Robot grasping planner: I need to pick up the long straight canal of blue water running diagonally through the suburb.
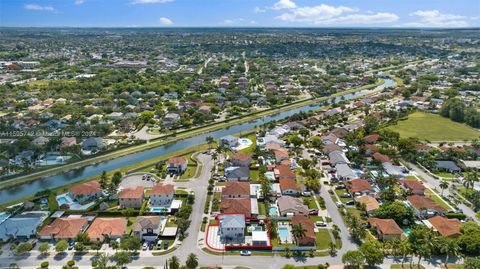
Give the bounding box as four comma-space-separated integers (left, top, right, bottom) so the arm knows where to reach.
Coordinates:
0, 79, 396, 204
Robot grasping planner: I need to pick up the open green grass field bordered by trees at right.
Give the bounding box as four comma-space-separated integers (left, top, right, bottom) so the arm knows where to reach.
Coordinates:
387, 112, 480, 141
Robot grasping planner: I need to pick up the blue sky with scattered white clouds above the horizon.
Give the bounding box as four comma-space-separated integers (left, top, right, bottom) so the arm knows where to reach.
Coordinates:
0, 0, 480, 28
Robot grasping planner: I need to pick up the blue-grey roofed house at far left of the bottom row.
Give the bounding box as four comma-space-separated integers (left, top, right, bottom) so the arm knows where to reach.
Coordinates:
0, 211, 49, 242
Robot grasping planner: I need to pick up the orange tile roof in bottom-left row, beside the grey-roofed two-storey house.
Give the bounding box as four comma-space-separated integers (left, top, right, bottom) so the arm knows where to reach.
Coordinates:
87, 218, 127, 239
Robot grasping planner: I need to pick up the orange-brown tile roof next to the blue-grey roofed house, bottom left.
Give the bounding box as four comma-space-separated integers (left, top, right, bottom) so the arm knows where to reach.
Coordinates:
38, 218, 88, 239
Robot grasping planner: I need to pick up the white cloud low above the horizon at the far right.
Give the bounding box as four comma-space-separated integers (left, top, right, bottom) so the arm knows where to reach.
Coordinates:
403, 9, 469, 27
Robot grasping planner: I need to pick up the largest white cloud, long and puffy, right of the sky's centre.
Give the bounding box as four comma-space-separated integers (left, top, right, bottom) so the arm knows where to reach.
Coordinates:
276, 4, 399, 25
